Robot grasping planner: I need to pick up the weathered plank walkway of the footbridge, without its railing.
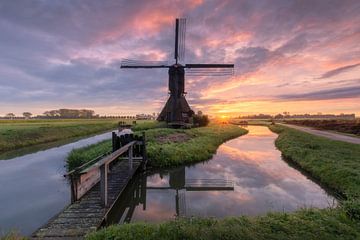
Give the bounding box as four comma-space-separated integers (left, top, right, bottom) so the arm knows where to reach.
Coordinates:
32, 160, 142, 239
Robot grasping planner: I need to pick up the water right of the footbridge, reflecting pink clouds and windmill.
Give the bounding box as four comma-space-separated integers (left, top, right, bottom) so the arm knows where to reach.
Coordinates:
109, 126, 336, 223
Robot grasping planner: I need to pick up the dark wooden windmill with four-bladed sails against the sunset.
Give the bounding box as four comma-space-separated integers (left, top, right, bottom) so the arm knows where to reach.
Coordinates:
121, 18, 234, 127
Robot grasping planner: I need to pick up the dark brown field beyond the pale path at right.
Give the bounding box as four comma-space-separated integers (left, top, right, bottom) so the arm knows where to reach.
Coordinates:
284, 120, 360, 136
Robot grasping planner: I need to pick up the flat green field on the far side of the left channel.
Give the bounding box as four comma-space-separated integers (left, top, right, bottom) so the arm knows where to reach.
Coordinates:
0, 119, 162, 158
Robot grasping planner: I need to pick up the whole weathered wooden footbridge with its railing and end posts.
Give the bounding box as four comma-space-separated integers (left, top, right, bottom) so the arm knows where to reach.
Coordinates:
31, 132, 146, 240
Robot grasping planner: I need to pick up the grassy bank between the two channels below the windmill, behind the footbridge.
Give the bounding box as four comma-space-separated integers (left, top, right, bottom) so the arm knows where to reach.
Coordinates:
67, 124, 247, 170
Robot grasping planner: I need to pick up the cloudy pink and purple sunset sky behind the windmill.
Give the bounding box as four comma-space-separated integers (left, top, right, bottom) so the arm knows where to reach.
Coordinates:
0, 0, 360, 116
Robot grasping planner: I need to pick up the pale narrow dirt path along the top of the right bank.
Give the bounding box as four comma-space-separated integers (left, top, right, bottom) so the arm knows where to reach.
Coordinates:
278, 123, 360, 144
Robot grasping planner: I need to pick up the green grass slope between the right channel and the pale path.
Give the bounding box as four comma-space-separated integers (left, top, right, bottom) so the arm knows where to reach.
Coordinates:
269, 125, 360, 197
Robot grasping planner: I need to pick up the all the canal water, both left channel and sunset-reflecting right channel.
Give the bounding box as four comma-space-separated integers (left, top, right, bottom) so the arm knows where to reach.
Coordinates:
0, 126, 336, 235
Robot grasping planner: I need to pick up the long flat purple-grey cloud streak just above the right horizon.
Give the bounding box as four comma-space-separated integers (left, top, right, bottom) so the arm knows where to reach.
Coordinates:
278, 86, 360, 101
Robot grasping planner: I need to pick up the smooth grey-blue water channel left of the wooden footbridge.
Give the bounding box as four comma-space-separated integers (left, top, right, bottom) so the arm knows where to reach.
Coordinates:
0, 133, 111, 236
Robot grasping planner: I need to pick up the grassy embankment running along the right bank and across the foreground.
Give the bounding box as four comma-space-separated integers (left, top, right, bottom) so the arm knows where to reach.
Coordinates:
87, 123, 360, 240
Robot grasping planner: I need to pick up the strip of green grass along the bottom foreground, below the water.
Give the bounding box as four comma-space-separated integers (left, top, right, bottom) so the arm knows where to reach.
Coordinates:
86, 209, 360, 240
